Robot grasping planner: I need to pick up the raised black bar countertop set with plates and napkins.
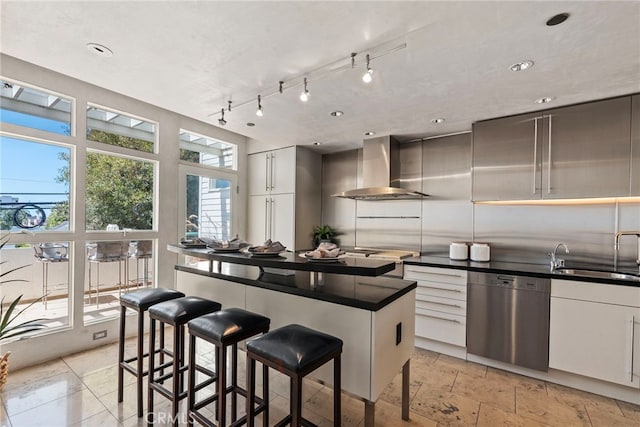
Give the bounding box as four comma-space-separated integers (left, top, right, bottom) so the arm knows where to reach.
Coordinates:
167, 245, 396, 277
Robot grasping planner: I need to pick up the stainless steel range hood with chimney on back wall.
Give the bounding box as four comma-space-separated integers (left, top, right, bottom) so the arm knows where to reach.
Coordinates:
332, 136, 429, 200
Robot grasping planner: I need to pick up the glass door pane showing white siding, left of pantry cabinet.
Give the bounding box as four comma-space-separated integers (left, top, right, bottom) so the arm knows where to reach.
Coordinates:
185, 175, 234, 240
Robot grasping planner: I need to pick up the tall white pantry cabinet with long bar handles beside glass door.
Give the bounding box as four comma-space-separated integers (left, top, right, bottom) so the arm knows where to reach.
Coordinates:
247, 147, 322, 250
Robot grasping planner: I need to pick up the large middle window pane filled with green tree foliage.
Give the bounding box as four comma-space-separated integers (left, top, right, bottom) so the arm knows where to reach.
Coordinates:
86, 152, 154, 230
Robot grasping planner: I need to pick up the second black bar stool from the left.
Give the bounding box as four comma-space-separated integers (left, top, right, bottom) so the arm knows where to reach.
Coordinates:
147, 296, 222, 427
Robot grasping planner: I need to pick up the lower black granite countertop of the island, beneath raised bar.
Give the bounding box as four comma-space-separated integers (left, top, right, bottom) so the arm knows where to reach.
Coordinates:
175, 263, 416, 311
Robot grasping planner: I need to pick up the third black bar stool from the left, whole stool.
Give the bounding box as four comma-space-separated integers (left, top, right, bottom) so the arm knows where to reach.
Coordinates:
188, 308, 271, 426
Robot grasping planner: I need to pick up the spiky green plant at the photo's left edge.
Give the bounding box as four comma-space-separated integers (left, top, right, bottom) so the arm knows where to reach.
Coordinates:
0, 235, 45, 390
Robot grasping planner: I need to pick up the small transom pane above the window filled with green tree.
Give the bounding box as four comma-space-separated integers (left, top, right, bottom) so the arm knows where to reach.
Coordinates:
87, 105, 156, 153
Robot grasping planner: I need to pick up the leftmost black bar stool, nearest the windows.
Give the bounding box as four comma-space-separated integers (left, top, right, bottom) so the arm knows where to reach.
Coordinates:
118, 288, 184, 417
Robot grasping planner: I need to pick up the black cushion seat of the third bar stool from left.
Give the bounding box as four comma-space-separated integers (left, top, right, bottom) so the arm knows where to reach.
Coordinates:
189, 308, 271, 344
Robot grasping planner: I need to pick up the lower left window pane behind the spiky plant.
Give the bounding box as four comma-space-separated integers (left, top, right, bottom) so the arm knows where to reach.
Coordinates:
0, 241, 71, 339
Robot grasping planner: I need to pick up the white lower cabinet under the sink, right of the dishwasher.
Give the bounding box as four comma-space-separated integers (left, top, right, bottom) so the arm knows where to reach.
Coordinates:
549, 280, 640, 388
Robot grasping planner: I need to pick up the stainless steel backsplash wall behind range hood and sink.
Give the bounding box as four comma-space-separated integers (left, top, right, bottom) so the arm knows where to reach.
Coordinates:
322, 134, 640, 268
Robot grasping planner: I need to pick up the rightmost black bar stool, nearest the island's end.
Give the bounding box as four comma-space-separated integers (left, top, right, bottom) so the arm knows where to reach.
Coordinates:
247, 325, 342, 427
